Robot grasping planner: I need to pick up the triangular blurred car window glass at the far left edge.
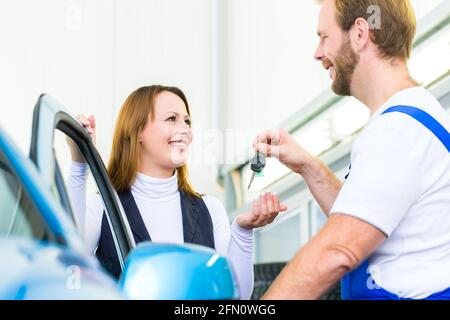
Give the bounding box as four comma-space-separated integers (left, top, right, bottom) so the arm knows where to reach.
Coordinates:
0, 152, 56, 242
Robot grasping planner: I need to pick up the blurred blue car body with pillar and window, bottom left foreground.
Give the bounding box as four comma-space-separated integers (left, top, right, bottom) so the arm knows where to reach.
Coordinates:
0, 128, 123, 300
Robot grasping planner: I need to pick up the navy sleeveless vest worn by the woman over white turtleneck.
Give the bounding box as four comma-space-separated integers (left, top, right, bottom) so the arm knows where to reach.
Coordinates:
95, 190, 215, 278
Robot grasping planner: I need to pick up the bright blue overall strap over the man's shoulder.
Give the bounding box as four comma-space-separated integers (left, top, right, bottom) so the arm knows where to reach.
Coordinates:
382, 106, 450, 152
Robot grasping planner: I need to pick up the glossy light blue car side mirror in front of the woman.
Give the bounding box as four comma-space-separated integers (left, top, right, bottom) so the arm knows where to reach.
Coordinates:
119, 242, 239, 300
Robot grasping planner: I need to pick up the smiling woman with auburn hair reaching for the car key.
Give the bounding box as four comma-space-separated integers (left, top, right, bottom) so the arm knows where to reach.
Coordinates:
68, 86, 287, 299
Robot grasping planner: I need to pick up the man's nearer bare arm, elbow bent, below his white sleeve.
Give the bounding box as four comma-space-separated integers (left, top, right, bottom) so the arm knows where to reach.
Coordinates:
262, 214, 386, 300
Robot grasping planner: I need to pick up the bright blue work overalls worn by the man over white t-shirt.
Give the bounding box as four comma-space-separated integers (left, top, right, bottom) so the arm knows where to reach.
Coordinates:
341, 106, 450, 300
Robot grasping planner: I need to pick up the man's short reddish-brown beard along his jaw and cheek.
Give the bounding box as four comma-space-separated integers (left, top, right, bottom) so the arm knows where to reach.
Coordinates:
331, 40, 359, 96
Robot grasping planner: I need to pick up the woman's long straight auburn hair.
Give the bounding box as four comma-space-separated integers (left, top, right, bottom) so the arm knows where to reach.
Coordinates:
108, 85, 201, 198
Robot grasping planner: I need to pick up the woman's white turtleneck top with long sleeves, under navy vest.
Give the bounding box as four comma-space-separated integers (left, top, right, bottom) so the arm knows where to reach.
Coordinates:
68, 162, 253, 299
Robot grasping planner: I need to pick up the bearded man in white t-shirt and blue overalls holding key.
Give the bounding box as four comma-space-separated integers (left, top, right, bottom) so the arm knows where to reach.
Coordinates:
254, 0, 450, 299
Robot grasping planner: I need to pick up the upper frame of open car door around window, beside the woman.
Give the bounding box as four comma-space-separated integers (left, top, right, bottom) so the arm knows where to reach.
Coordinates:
30, 94, 135, 276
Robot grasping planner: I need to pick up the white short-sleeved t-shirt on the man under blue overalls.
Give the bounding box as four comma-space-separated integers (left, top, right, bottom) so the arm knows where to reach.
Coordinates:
331, 87, 450, 299
